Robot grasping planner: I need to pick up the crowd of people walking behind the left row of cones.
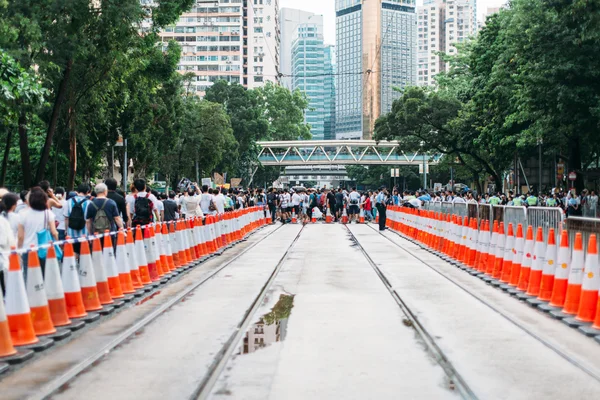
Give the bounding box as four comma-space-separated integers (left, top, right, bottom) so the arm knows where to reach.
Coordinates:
0, 178, 266, 289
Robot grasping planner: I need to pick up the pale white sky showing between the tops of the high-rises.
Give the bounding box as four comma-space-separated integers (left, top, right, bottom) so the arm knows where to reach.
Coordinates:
279, 0, 506, 44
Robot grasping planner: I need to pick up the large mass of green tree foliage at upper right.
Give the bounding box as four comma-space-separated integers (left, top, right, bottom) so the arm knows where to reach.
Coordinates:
375, 0, 600, 192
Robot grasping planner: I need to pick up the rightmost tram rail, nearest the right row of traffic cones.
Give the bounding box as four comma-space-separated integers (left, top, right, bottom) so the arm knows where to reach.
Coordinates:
369, 222, 600, 388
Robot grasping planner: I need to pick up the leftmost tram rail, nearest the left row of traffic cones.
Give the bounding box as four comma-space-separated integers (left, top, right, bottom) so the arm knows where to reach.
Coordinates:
28, 225, 283, 400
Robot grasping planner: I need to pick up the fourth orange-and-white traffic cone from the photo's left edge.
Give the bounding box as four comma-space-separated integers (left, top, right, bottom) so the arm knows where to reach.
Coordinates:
44, 246, 71, 326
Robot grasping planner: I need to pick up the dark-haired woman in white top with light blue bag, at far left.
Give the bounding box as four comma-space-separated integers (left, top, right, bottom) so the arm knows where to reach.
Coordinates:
17, 187, 58, 282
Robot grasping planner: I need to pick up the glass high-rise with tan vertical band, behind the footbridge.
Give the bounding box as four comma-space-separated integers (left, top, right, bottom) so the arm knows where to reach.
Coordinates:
335, 0, 417, 139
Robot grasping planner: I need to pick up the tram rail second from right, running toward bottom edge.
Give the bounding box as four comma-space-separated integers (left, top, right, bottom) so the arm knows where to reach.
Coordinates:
345, 224, 477, 399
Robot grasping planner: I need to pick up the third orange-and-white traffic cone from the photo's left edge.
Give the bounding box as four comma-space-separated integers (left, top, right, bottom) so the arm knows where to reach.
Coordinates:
27, 250, 56, 335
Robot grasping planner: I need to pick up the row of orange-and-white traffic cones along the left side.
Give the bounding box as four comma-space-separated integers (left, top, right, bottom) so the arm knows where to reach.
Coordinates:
0, 207, 267, 370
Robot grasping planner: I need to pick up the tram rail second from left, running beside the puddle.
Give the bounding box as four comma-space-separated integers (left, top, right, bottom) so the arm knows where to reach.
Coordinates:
189, 226, 304, 400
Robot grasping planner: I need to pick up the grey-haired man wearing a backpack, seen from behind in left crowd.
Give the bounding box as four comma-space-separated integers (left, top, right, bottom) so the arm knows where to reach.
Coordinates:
86, 183, 123, 234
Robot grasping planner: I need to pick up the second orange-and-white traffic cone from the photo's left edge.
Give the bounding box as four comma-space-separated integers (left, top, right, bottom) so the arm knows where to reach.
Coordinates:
6, 248, 39, 346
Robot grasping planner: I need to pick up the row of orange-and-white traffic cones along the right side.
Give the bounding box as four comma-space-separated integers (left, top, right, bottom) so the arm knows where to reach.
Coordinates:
388, 207, 600, 341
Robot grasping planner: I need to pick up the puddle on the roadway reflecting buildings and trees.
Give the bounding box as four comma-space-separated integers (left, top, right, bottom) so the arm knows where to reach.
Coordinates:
238, 294, 294, 354
